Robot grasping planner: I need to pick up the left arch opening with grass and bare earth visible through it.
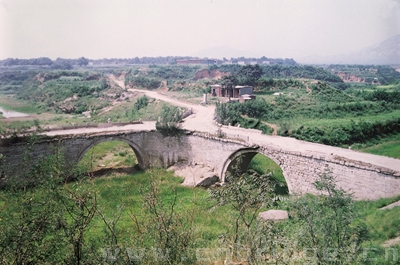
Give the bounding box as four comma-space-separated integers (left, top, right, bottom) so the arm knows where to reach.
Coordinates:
78, 139, 143, 177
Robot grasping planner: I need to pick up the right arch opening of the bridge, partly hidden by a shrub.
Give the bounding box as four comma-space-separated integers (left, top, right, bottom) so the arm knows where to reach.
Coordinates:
221, 148, 290, 195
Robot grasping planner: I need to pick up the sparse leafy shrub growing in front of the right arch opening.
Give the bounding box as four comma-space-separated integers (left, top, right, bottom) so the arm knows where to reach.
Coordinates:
210, 161, 285, 262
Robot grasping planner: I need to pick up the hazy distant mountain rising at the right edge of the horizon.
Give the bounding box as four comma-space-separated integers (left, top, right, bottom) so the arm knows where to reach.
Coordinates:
298, 34, 400, 65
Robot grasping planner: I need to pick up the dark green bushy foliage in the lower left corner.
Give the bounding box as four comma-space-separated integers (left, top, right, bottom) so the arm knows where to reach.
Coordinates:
0, 139, 106, 264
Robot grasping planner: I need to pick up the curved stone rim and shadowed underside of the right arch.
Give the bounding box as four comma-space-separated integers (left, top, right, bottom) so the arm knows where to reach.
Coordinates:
220, 147, 292, 193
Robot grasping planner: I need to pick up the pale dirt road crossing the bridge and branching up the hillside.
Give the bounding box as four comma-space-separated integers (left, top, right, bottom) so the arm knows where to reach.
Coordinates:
45, 89, 400, 172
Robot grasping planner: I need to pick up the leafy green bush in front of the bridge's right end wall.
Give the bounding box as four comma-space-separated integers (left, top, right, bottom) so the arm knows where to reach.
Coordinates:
292, 171, 368, 264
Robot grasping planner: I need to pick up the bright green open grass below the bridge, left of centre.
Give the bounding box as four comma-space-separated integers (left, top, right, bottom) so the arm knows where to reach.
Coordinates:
69, 169, 229, 247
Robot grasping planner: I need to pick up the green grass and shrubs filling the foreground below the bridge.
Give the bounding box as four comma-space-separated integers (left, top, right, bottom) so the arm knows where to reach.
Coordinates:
0, 143, 396, 264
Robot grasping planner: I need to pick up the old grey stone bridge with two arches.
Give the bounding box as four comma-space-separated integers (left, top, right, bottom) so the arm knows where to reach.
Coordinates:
0, 130, 400, 199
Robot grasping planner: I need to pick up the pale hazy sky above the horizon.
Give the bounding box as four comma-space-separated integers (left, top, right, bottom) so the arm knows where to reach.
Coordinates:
0, 0, 400, 60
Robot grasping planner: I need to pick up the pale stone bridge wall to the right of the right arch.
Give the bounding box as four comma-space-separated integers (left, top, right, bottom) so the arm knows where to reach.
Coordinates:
260, 147, 400, 200
